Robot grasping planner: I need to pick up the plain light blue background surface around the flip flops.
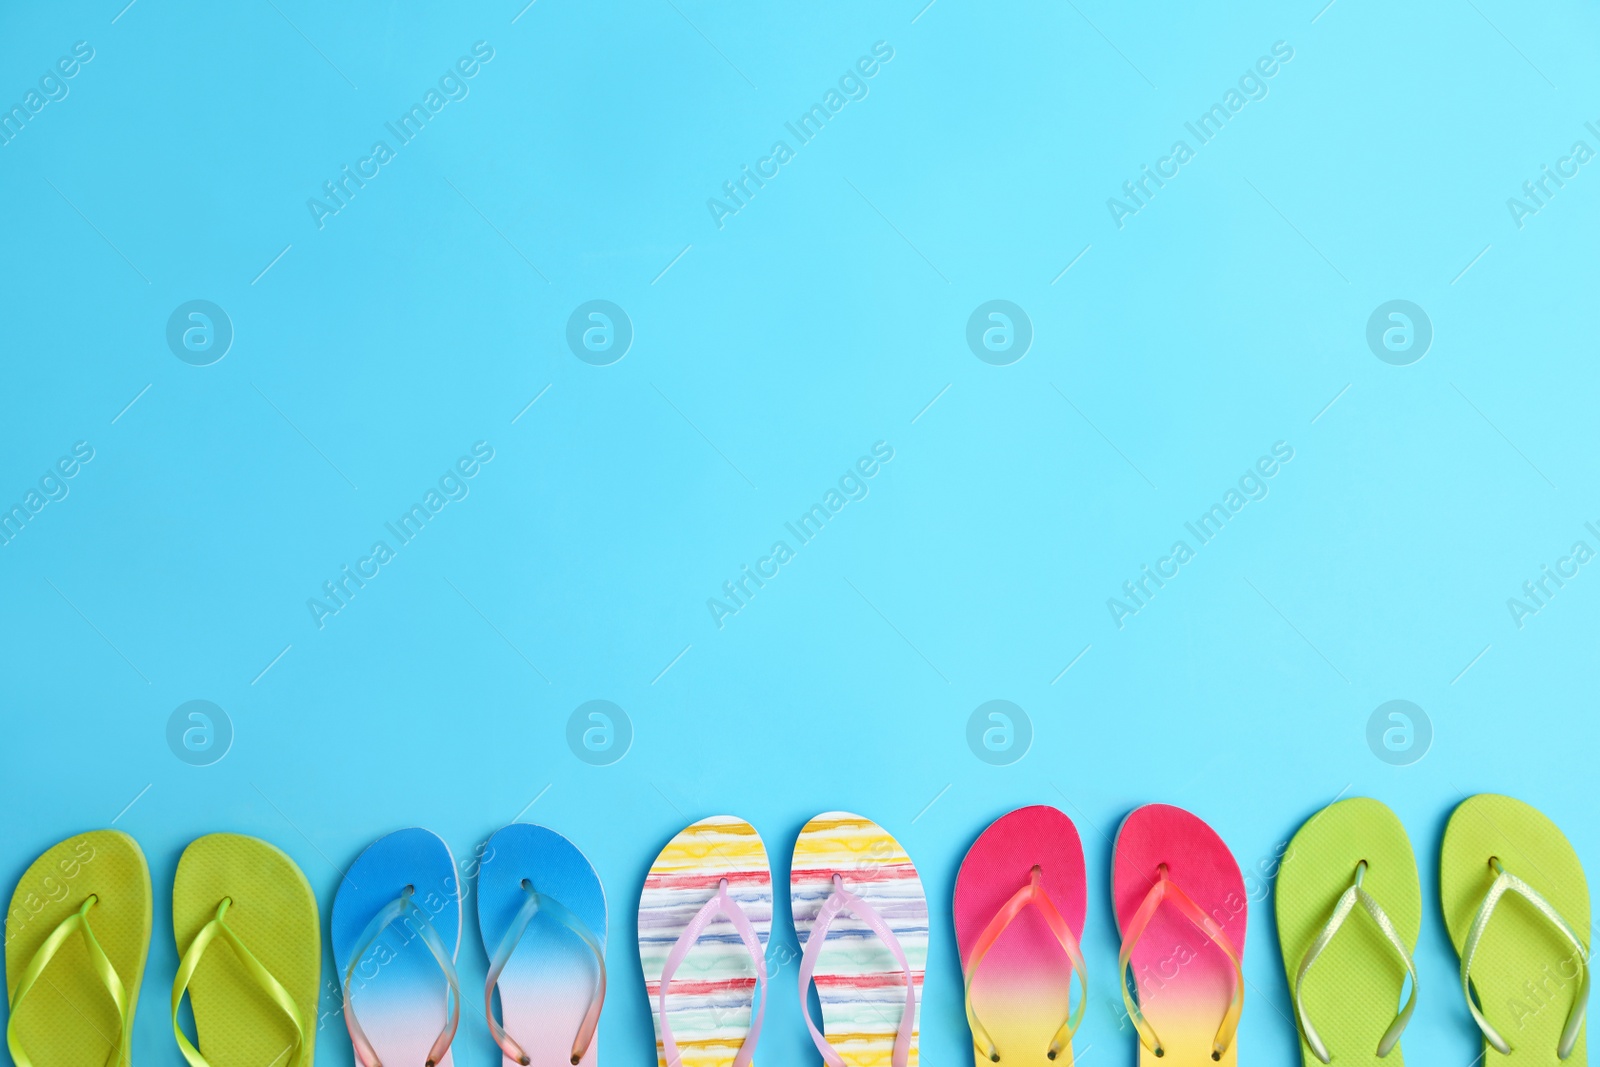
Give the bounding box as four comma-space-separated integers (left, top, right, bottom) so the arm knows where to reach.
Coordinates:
0, 0, 1600, 1067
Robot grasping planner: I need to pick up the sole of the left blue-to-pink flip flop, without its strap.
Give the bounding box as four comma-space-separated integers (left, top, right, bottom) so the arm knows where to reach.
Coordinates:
328, 829, 467, 1067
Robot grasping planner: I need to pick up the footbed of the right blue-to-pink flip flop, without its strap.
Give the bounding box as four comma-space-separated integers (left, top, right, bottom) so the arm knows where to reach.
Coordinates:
466, 822, 606, 1067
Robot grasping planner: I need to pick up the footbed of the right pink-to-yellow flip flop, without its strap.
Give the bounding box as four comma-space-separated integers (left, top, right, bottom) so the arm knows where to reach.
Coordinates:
1112, 805, 1250, 1067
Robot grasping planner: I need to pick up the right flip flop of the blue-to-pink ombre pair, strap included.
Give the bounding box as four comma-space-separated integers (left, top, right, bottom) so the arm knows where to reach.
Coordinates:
478, 822, 606, 1067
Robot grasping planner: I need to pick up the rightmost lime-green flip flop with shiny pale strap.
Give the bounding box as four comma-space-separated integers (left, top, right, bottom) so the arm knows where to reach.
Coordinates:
1438, 793, 1589, 1067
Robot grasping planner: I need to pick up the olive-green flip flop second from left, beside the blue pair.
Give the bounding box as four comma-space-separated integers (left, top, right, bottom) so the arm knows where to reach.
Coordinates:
173, 833, 322, 1067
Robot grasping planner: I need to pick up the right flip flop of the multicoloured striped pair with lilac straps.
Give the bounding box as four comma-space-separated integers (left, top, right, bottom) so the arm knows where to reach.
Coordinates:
789, 811, 928, 1067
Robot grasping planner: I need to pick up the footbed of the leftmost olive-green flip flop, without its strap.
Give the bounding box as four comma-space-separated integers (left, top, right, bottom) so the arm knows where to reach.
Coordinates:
5, 830, 150, 1067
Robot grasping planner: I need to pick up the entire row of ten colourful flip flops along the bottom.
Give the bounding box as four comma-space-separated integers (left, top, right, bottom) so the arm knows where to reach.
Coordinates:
6, 795, 1589, 1067
